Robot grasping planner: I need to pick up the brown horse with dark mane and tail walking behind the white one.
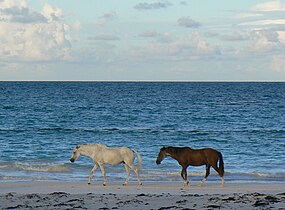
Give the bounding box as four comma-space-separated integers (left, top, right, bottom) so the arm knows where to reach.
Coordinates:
156, 147, 225, 187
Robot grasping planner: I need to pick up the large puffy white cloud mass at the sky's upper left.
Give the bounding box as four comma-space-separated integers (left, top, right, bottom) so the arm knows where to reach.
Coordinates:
0, 0, 71, 62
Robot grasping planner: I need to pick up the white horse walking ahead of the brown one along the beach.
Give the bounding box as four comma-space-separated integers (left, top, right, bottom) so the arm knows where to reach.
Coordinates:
70, 144, 142, 186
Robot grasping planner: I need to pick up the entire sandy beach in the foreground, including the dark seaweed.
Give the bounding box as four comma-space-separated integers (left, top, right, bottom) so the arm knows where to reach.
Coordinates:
0, 181, 285, 209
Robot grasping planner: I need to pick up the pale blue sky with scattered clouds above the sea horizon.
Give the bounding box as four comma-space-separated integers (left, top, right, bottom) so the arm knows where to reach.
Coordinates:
0, 0, 285, 82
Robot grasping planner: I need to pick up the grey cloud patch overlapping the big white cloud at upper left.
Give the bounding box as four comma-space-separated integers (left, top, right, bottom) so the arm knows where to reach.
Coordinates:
0, 7, 47, 23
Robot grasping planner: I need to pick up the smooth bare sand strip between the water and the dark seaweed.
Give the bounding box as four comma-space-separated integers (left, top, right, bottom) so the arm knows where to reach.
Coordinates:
0, 180, 285, 195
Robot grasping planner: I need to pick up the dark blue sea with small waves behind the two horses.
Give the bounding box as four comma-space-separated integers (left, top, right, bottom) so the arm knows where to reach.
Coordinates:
0, 82, 285, 183
